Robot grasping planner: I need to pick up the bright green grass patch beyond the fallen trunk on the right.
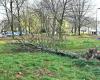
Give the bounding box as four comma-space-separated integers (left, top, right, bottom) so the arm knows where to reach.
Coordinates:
57, 36, 100, 50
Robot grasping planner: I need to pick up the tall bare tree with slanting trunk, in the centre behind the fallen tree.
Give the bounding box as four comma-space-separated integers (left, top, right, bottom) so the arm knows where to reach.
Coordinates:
41, 0, 71, 39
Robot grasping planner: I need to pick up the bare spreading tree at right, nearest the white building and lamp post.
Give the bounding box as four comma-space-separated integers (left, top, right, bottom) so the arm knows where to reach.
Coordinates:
67, 0, 91, 35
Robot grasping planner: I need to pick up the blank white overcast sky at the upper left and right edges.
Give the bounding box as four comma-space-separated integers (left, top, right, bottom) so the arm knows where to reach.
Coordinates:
0, 0, 100, 20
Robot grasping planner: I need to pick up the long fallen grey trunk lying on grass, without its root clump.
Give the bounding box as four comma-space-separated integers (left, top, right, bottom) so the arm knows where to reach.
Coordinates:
11, 43, 81, 59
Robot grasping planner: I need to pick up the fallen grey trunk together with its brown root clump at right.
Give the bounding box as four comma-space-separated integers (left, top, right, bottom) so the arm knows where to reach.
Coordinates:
25, 43, 100, 60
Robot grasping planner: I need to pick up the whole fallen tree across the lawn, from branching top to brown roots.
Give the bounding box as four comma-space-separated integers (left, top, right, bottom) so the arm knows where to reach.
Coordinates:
11, 43, 100, 60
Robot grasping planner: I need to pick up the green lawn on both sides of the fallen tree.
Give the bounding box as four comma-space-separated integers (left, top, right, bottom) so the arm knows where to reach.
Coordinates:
0, 37, 100, 80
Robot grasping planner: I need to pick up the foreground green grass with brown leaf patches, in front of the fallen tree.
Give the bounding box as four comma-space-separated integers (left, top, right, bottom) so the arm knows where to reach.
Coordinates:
0, 52, 100, 80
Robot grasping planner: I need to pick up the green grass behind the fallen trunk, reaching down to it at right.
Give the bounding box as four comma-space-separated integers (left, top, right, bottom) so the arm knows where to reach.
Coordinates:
48, 36, 100, 53
